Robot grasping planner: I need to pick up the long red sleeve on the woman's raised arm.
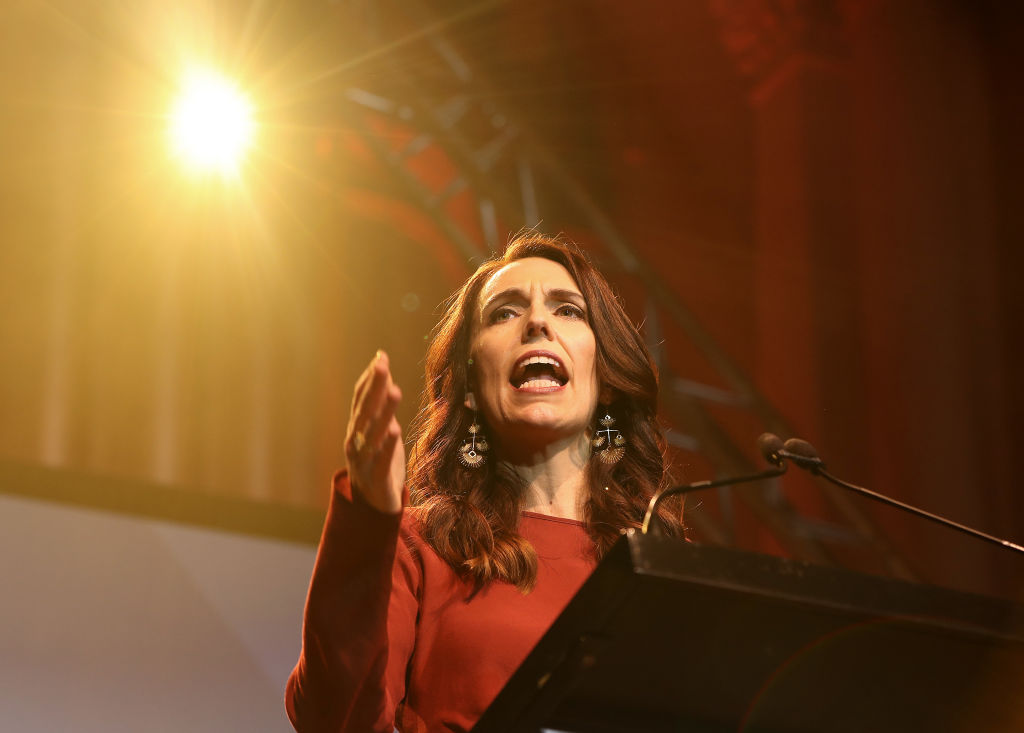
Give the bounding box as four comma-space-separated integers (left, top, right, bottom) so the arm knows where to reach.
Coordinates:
285, 473, 420, 733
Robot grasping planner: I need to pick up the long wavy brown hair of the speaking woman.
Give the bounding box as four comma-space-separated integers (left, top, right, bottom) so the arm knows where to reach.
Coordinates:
409, 231, 683, 593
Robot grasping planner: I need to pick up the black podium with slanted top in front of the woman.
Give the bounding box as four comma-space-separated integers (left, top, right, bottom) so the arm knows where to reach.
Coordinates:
473, 532, 1024, 733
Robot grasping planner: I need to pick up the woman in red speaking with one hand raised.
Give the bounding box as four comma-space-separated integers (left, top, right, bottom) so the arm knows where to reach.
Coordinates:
286, 233, 682, 732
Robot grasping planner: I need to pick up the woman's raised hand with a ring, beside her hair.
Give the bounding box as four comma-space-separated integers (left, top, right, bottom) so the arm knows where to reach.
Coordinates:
345, 351, 406, 514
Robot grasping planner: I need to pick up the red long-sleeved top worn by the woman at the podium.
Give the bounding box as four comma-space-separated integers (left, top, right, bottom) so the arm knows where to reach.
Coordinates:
285, 473, 595, 733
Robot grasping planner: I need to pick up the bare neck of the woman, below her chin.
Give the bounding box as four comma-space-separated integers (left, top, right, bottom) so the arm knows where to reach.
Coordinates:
499, 435, 590, 520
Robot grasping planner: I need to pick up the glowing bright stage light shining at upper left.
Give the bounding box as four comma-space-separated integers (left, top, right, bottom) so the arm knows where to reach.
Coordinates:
170, 72, 254, 175
